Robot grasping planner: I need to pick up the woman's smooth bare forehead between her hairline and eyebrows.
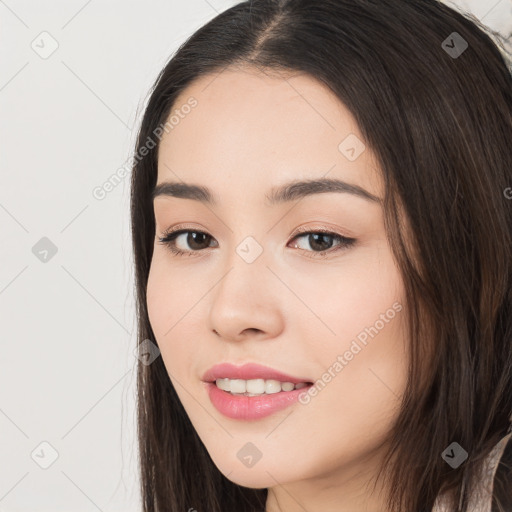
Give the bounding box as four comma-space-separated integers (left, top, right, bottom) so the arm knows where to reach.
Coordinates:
158, 68, 381, 202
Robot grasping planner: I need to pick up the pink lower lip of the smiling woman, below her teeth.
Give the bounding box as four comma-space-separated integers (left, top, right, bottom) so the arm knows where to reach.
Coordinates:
205, 382, 312, 420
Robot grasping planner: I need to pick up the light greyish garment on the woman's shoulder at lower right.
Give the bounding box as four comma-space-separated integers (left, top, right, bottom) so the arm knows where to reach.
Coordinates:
432, 429, 512, 512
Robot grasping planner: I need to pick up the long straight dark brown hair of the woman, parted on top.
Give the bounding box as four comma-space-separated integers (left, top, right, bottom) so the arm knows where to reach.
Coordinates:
131, 0, 512, 512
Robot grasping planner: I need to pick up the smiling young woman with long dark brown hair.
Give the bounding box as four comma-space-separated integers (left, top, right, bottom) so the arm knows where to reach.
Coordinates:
131, 0, 512, 512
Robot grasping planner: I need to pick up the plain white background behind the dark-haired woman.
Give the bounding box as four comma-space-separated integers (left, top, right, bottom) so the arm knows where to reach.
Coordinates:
0, 0, 512, 512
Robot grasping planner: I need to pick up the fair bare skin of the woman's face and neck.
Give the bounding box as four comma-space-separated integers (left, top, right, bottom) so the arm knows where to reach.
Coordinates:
147, 68, 408, 512
